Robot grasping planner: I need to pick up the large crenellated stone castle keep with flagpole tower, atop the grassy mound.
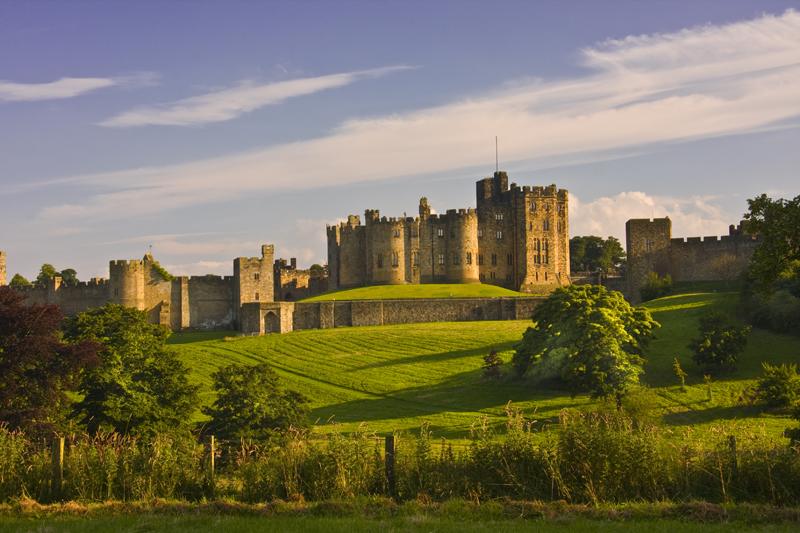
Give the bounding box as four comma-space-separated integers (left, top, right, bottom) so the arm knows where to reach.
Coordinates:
327, 172, 570, 292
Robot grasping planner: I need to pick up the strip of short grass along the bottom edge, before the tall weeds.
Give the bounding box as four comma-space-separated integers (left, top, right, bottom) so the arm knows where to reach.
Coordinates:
0, 498, 800, 533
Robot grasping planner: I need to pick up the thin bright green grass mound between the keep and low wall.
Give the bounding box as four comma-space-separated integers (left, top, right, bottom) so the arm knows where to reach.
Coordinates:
296, 283, 532, 302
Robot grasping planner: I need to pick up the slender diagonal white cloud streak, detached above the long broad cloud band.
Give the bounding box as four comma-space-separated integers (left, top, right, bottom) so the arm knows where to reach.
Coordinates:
100, 66, 411, 128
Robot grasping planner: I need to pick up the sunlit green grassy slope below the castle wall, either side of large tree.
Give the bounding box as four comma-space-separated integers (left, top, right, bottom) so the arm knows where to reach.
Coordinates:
171, 286, 800, 438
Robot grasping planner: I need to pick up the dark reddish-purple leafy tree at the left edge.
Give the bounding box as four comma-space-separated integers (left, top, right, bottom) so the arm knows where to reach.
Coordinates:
0, 287, 99, 432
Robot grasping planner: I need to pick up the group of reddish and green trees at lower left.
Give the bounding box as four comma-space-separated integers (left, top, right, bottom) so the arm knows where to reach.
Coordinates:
0, 287, 307, 439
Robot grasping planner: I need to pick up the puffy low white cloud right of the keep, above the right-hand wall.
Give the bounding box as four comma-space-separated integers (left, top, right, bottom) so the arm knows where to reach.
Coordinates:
569, 191, 734, 241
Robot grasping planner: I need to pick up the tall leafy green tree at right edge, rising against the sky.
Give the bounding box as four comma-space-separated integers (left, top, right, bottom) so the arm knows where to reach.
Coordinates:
744, 194, 800, 290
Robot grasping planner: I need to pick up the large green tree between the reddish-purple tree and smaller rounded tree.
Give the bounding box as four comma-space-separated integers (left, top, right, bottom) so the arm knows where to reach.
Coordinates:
65, 304, 197, 433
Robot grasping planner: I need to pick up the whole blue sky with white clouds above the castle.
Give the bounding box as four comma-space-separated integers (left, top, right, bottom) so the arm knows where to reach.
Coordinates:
0, 0, 800, 279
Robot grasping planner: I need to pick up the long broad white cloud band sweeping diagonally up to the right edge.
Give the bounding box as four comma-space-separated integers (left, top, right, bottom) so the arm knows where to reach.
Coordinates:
34, 11, 800, 220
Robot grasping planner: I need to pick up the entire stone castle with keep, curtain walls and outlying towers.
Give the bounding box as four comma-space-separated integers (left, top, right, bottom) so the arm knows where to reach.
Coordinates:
0, 172, 760, 334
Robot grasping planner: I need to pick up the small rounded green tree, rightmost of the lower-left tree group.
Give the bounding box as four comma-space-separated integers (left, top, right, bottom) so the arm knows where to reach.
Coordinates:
203, 364, 308, 440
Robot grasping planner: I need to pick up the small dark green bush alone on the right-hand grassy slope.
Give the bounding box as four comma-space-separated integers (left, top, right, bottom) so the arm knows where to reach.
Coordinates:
689, 313, 751, 374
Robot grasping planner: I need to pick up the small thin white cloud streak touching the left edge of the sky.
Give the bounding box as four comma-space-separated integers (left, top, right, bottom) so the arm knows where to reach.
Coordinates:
0, 72, 157, 102
